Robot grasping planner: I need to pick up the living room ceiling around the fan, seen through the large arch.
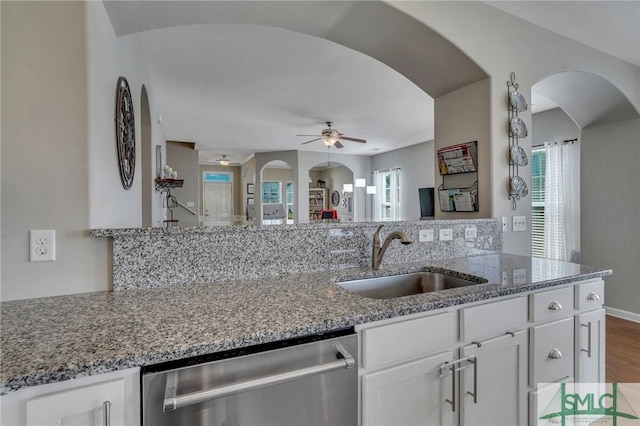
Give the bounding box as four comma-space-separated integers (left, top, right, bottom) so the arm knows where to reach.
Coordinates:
138, 24, 434, 161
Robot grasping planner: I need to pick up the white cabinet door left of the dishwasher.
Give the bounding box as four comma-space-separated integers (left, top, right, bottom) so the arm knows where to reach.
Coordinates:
26, 379, 125, 426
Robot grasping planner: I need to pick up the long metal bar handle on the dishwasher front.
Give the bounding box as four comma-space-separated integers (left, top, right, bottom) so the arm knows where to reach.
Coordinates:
163, 342, 356, 412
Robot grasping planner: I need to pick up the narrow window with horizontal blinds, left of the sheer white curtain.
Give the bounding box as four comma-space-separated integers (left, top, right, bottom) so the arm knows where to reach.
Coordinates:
531, 148, 546, 257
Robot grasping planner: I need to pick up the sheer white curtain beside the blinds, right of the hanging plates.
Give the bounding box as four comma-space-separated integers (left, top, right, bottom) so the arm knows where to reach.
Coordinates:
544, 142, 579, 261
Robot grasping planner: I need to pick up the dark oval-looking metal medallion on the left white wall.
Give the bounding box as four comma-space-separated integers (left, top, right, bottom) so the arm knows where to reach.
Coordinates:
116, 77, 136, 189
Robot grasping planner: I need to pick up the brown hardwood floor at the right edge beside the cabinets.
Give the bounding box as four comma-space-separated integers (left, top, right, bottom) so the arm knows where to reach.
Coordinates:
605, 315, 640, 383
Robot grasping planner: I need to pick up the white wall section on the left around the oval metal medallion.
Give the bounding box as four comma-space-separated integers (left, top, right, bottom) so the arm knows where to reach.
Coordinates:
86, 2, 166, 228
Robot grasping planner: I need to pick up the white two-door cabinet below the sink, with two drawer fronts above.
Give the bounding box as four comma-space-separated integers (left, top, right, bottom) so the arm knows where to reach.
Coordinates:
358, 296, 528, 426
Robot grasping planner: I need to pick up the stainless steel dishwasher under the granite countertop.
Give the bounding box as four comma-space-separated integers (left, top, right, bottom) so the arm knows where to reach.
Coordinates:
142, 329, 358, 426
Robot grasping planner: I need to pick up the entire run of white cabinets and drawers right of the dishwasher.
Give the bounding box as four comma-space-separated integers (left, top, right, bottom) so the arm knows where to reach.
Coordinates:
356, 279, 605, 426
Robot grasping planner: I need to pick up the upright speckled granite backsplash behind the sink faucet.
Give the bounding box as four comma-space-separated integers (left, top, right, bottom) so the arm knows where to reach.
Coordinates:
92, 219, 502, 291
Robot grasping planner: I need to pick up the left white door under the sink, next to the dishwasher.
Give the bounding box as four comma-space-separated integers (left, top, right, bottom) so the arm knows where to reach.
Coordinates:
362, 352, 454, 426
